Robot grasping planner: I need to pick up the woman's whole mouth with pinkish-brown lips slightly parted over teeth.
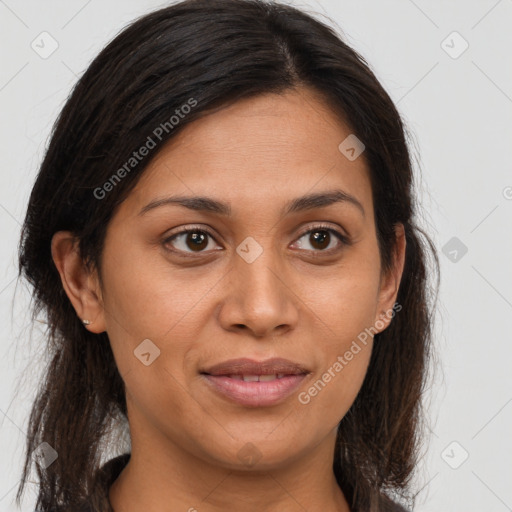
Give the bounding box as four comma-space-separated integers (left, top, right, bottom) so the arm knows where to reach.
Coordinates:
200, 358, 311, 407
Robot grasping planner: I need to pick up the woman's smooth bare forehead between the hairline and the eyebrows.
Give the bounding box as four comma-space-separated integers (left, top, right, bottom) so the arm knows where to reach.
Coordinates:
122, 88, 372, 218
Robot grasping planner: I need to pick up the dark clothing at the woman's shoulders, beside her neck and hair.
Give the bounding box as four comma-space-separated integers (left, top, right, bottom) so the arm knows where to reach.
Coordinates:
72, 453, 407, 512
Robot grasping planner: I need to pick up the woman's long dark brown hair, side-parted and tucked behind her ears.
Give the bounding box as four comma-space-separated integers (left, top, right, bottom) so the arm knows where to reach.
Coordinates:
17, 0, 439, 512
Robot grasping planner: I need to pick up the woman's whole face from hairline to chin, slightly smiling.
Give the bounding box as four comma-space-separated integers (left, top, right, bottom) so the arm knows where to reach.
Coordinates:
84, 89, 403, 469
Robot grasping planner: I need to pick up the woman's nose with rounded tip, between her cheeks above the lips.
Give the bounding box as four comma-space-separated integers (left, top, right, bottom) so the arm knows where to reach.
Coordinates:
218, 243, 300, 338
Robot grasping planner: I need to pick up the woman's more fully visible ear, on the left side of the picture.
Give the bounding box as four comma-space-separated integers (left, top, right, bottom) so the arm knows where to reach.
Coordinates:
51, 231, 106, 334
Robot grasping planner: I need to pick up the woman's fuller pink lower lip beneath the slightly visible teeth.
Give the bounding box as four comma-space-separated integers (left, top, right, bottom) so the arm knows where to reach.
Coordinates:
202, 374, 306, 407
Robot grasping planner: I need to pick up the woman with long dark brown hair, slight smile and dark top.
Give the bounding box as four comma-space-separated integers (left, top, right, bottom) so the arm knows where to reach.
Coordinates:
17, 0, 437, 512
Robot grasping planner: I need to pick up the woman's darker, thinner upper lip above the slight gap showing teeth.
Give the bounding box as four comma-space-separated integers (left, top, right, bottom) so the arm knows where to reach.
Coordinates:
201, 357, 309, 375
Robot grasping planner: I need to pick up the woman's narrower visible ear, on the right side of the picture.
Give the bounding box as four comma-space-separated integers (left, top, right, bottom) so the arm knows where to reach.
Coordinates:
374, 223, 406, 332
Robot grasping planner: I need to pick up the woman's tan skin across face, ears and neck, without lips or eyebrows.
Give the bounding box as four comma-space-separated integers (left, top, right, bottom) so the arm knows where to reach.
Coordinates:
52, 88, 405, 512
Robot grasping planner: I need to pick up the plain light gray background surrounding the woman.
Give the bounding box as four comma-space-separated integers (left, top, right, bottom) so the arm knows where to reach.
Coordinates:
0, 0, 512, 512
